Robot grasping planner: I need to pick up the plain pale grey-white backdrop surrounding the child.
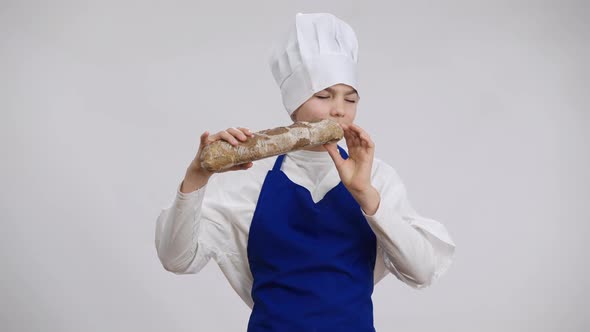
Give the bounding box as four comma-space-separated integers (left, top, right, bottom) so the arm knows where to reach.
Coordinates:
0, 0, 590, 332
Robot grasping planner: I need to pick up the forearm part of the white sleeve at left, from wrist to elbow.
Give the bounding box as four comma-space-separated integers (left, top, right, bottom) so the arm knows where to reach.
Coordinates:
155, 183, 212, 274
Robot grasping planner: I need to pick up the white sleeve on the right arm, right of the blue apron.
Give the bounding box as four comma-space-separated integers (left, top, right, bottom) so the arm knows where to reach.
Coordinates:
363, 162, 455, 289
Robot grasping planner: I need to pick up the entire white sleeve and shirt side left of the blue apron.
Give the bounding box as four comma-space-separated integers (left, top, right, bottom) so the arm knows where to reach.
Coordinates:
155, 158, 273, 284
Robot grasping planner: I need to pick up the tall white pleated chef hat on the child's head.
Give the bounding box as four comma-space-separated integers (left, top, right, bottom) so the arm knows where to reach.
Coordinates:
269, 13, 358, 115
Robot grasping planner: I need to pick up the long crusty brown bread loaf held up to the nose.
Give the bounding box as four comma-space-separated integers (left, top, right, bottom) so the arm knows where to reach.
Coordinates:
201, 119, 344, 172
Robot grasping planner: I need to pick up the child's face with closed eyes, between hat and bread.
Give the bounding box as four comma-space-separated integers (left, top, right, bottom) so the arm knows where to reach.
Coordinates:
291, 84, 359, 125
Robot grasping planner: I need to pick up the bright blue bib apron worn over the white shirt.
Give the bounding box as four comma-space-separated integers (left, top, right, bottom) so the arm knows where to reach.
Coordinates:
247, 146, 377, 332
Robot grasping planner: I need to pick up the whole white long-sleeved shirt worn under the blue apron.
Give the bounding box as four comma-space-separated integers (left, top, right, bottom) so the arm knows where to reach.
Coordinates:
155, 145, 455, 308
